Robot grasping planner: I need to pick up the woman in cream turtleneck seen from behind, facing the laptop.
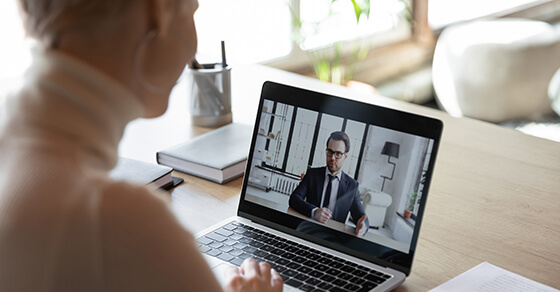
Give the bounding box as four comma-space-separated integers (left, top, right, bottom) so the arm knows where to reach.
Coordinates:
0, 0, 282, 291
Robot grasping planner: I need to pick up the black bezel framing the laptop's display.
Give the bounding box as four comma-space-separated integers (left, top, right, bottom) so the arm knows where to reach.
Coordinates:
238, 81, 443, 276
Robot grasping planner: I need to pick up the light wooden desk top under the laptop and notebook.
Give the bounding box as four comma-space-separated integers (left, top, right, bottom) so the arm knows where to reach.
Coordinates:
120, 65, 560, 291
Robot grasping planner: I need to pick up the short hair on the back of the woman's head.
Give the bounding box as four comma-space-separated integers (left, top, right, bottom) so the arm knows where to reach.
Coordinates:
18, 0, 132, 47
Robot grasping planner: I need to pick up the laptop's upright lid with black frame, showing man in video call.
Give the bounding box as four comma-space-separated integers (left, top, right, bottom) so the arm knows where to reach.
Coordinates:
239, 82, 442, 274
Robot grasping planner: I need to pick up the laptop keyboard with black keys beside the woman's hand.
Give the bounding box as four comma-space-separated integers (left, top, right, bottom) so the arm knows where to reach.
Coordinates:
197, 222, 391, 291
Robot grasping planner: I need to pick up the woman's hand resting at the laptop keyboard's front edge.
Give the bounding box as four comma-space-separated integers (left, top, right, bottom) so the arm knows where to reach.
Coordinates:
224, 258, 284, 292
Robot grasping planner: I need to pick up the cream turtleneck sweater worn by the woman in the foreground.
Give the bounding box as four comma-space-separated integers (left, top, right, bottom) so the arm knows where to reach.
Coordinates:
0, 50, 221, 291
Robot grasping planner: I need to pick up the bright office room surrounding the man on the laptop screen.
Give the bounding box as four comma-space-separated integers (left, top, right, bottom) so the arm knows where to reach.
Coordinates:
245, 100, 433, 253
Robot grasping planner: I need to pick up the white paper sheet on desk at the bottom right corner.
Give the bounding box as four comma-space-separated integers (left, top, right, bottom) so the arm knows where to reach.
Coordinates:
430, 262, 560, 292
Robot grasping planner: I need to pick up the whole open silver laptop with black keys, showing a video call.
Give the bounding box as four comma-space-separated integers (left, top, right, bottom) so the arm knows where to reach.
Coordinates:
196, 81, 443, 291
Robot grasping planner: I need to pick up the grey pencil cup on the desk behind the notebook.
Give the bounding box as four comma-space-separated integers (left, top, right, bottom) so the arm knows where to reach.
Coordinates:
186, 64, 232, 127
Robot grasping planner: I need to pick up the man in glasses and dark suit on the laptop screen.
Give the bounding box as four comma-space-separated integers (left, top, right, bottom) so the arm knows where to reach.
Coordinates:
289, 131, 369, 236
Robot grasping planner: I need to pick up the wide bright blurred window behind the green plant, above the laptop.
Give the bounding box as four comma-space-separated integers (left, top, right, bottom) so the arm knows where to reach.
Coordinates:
195, 0, 411, 69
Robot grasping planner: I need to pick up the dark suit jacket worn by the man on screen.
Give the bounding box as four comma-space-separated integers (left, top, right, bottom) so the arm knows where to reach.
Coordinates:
289, 167, 369, 229
